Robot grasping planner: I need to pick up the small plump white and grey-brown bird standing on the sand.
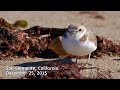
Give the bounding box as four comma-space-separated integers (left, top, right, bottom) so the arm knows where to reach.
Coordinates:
61, 24, 97, 64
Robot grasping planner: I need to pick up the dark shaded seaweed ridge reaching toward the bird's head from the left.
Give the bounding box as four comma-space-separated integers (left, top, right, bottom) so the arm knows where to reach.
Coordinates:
23, 26, 67, 39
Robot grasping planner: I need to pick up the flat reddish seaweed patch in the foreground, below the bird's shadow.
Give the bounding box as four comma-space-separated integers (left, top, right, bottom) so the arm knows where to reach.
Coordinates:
22, 63, 84, 79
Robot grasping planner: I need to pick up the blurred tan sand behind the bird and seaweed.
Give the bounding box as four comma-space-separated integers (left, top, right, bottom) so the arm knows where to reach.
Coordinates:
0, 11, 120, 43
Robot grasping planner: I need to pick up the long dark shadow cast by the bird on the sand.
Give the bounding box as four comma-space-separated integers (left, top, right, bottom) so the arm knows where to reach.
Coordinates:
14, 59, 74, 67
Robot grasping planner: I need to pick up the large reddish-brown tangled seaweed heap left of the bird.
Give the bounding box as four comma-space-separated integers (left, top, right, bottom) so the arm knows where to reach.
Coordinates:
0, 18, 62, 59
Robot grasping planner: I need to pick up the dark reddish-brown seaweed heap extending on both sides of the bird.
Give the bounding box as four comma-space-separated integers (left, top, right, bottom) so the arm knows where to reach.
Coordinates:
0, 18, 120, 59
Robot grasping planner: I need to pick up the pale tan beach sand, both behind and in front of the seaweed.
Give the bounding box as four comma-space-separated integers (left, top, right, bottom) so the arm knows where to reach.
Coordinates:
0, 11, 120, 79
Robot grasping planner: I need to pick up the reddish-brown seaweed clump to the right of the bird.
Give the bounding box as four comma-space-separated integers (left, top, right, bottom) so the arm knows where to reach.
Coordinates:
92, 36, 120, 57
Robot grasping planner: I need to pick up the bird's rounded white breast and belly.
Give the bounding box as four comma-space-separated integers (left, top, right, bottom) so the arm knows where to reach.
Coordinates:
62, 37, 97, 56
